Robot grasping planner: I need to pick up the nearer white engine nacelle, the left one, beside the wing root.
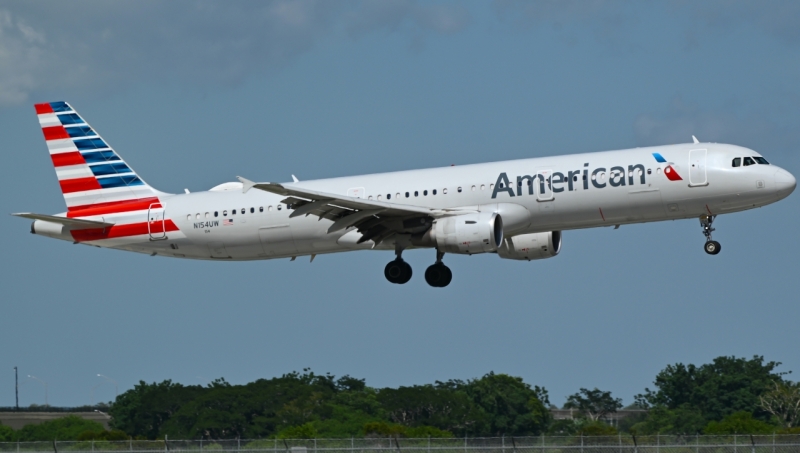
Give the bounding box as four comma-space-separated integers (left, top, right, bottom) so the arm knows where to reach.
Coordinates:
430, 212, 503, 255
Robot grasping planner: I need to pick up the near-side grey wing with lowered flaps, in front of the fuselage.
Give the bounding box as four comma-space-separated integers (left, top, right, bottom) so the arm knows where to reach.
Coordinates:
238, 176, 472, 245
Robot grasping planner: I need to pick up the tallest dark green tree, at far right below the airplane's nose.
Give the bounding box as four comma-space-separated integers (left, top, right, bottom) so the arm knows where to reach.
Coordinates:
636, 356, 785, 421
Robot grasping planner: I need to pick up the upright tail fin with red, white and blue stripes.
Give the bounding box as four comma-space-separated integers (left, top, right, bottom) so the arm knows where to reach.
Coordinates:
35, 102, 166, 217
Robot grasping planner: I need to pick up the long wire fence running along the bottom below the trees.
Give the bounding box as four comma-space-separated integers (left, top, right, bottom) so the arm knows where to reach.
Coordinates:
0, 435, 800, 453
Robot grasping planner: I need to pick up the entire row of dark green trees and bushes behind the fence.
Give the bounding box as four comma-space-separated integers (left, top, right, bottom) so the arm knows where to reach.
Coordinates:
0, 356, 800, 441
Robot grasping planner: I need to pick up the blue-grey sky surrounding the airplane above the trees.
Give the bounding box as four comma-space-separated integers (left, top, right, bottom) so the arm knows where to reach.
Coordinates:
0, 0, 800, 406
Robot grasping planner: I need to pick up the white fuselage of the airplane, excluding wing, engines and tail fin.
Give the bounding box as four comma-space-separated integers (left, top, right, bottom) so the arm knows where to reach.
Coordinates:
34, 143, 795, 260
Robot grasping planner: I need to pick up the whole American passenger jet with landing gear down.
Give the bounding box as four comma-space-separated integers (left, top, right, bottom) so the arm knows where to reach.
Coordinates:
12, 102, 797, 287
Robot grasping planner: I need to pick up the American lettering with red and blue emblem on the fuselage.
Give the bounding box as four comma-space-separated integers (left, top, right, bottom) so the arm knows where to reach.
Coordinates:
492, 153, 683, 198
